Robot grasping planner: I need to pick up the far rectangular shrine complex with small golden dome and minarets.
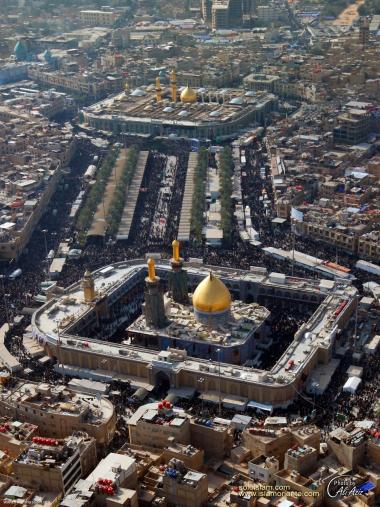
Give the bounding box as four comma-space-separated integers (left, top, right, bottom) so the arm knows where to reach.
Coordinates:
82, 81, 276, 139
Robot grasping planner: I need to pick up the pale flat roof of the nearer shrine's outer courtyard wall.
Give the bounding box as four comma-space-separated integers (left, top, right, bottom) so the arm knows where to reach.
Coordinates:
33, 260, 356, 392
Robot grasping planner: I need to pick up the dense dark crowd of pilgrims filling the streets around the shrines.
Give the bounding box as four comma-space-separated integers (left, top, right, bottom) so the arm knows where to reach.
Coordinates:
0, 138, 379, 436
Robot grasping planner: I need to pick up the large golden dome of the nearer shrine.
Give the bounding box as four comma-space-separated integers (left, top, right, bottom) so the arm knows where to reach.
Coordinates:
193, 273, 231, 313
